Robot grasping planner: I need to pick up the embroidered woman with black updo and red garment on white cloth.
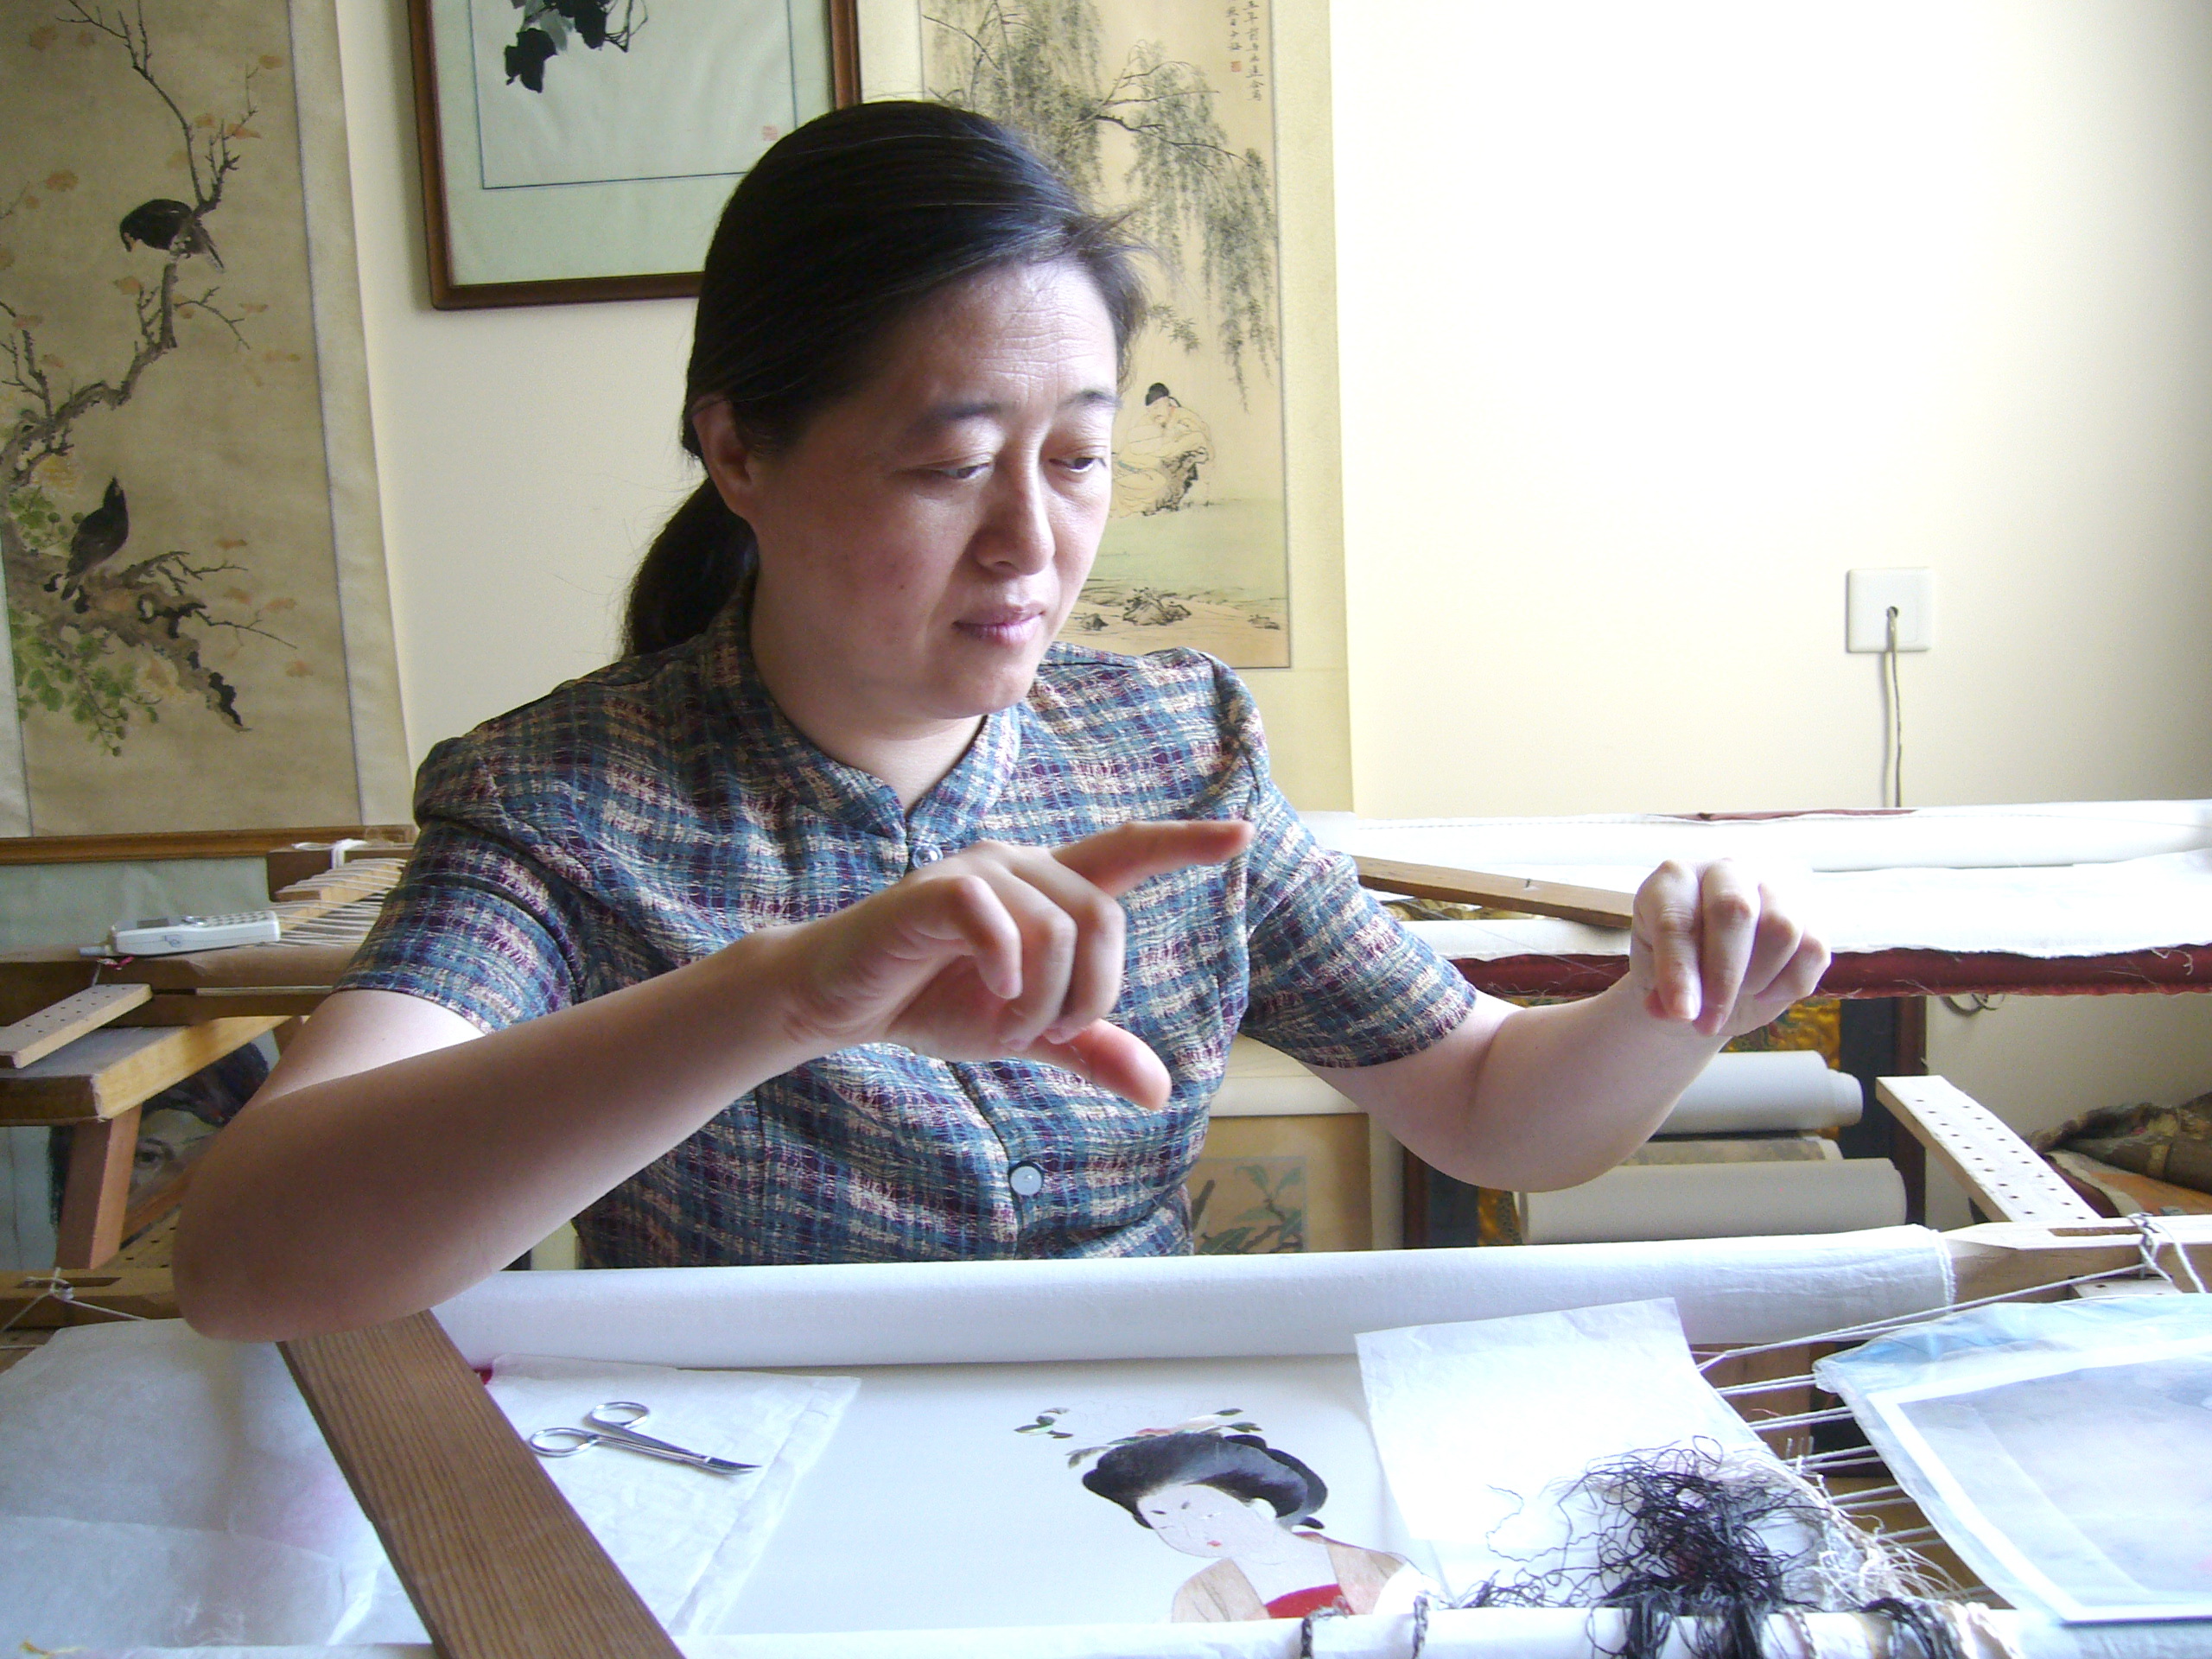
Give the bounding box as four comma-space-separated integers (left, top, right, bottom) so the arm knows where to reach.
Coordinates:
1084, 1433, 1425, 1621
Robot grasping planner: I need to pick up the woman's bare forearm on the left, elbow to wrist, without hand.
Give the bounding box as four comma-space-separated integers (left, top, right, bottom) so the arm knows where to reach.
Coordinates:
177, 929, 814, 1340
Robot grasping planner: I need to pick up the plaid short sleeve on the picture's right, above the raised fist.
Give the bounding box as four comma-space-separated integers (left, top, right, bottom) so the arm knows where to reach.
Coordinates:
1243, 772, 1476, 1066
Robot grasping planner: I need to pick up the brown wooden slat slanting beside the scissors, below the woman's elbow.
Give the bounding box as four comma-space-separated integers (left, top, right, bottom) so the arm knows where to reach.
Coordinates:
281, 1314, 679, 1659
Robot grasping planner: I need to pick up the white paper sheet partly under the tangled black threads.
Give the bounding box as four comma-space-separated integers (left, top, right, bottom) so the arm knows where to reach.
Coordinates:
1360, 1300, 1781, 1595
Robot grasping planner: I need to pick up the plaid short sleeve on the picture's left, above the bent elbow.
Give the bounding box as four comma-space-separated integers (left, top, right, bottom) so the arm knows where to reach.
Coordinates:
339, 743, 580, 1031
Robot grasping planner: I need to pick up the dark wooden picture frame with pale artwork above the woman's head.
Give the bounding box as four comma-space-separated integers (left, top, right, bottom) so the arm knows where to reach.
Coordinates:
407, 0, 861, 309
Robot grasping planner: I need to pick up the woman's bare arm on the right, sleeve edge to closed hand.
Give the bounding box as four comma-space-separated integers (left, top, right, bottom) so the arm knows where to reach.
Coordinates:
1314, 861, 1827, 1192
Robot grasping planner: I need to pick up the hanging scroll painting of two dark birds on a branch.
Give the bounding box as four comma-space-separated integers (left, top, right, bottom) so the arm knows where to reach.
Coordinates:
0, 0, 407, 834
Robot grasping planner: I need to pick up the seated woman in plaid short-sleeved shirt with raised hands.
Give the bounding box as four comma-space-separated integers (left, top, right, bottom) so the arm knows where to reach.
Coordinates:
177, 104, 1825, 1338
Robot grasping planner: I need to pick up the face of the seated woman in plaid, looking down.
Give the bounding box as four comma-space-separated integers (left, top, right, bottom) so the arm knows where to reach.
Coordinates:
699, 264, 1117, 736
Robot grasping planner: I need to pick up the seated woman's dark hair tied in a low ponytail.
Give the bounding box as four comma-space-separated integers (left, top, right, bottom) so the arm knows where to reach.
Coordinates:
624, 102, 1144, 655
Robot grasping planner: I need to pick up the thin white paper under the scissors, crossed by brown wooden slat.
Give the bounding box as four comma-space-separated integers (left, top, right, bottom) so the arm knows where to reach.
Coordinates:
0, 1327, 854, 1650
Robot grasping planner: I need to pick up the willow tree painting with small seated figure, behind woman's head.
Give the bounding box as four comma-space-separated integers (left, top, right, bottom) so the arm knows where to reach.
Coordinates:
923, 0, 1289, 668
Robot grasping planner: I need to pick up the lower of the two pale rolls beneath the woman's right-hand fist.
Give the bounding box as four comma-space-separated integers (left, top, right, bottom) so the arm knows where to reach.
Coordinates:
1524, 1157, 1904, 1245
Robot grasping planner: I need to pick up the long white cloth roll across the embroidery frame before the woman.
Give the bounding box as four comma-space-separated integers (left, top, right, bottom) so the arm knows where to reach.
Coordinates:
435, 1230, 1951, 1367
